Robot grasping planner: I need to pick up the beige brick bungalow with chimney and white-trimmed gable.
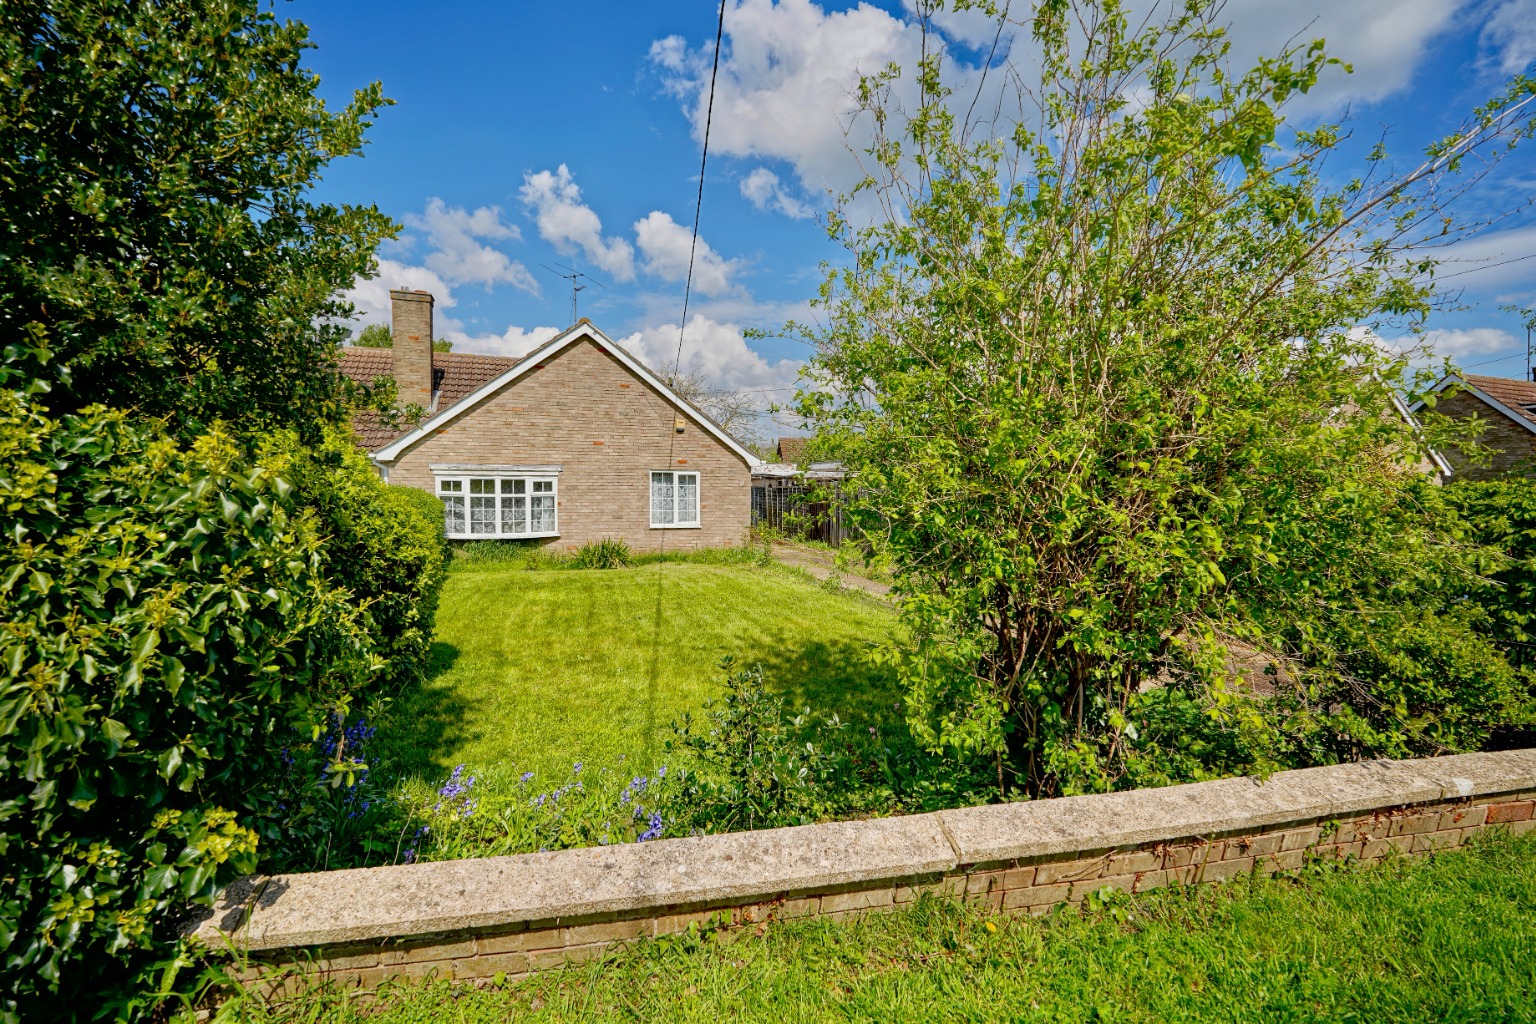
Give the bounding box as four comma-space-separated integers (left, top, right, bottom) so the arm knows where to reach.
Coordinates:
341, 290, 759, 551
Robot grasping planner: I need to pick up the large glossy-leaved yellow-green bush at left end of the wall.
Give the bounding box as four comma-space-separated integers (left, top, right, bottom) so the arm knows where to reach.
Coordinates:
0, 356, 379, 1021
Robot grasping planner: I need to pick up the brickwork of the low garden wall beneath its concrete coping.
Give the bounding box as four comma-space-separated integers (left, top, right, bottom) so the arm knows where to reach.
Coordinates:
233, 797, 1536, 998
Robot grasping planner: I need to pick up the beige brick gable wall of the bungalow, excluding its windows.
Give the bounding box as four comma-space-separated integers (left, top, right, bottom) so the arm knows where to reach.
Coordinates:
377, 339, 751, 551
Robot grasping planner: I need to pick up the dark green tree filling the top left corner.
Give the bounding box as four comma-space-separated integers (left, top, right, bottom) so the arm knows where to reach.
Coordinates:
0, 0, 396, 434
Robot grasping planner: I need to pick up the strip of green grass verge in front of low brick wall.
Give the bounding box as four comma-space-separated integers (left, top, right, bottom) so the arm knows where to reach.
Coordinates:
213, 835, 1536, 1024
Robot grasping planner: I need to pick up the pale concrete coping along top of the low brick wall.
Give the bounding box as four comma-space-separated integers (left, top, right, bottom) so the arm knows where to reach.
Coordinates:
189, 749, 1536, 952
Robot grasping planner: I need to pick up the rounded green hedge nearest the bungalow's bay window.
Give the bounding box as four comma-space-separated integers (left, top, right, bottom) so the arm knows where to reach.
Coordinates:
258, 425, 449, 682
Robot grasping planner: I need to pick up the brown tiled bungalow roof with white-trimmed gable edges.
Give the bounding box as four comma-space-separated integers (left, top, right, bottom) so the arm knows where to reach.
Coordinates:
351, 318, 762, 467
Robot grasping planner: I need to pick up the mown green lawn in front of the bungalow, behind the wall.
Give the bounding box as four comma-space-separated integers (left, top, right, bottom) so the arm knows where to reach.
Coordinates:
381, 552, 897, 785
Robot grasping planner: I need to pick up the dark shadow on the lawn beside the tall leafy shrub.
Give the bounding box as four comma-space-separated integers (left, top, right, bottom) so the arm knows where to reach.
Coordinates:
736, 640, 902, 725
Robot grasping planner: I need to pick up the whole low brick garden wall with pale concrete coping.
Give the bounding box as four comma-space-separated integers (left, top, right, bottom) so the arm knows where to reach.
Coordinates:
190, 749, 1536, 993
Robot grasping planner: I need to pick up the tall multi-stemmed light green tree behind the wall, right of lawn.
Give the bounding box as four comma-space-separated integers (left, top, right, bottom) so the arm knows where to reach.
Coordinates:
800, 0, 1536, 794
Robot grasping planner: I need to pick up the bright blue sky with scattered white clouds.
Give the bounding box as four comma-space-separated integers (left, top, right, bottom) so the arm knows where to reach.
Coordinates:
290, 0, 1536, 432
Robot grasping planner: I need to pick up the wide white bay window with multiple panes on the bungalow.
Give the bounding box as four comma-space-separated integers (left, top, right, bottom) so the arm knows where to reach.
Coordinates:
432, 467, 559, 540
